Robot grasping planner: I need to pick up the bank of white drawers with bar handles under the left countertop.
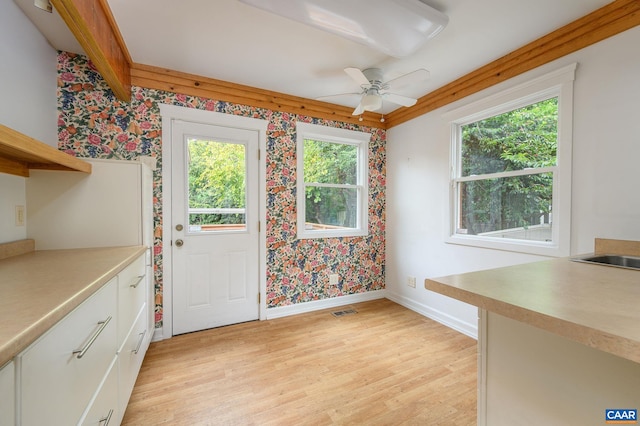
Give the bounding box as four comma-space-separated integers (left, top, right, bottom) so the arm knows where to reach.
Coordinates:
15, 254, 151, 426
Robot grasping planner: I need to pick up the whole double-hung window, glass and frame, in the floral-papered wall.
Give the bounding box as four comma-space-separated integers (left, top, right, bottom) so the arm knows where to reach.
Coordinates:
296, 123, 371, 238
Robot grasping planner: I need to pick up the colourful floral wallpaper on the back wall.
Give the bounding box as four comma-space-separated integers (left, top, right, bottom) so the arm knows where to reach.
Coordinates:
58, 52, 386, 327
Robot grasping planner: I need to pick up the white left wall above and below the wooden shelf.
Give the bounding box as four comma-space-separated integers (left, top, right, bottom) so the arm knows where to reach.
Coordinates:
0, 0, 58, 243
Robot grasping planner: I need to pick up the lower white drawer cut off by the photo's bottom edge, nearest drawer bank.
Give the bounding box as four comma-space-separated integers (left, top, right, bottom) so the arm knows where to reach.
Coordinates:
79, 357, 120, 426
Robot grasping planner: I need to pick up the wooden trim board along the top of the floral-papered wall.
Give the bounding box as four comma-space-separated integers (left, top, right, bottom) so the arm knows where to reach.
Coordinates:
131, 63, 386, 129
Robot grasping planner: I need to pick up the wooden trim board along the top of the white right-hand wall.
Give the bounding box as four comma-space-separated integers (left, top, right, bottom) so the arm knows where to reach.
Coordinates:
386, 0, 640, 128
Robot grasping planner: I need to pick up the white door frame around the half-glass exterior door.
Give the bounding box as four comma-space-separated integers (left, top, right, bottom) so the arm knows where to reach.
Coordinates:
162, 104, 269, 340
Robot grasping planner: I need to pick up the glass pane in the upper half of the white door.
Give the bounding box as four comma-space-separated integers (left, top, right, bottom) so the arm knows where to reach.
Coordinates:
187, 138, 246, 233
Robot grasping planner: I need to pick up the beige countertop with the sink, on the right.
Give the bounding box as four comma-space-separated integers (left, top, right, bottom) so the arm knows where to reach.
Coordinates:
424, 258, 640, 363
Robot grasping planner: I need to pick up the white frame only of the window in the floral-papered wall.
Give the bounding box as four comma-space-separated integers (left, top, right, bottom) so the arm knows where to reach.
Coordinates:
296, 122, 371, 239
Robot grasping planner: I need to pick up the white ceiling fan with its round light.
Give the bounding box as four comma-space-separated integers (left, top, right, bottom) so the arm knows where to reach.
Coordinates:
317, 68, 429, 115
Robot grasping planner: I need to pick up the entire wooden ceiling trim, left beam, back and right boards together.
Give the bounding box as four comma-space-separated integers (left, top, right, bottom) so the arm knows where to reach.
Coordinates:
57, 0, 640, 129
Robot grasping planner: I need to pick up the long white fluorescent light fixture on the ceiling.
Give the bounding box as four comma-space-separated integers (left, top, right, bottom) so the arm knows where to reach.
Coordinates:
240, 0, 449, 58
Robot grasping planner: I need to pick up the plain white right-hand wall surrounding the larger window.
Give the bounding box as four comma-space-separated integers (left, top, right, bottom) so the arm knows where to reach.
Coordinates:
387, 27, 640, 335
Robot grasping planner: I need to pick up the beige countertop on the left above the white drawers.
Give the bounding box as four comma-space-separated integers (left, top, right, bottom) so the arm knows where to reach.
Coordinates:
0, 246, 145, 367
